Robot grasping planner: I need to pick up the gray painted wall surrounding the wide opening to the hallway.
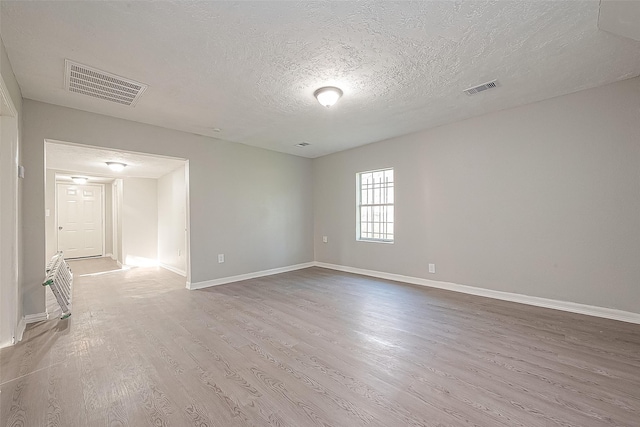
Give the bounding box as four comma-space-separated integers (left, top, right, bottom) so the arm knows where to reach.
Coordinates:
23, 100, 313, 314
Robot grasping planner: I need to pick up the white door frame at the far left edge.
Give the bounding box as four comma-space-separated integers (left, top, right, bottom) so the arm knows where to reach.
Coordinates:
0, 75, 20, 347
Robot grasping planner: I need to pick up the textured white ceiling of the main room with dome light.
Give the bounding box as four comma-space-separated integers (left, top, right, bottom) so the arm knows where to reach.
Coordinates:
0, 1, 640, 157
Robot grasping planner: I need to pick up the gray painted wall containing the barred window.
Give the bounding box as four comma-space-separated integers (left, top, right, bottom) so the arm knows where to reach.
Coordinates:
313, 78, 640, 313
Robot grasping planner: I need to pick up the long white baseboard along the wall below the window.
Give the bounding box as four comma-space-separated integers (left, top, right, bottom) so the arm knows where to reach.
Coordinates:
314, 262, 640, 324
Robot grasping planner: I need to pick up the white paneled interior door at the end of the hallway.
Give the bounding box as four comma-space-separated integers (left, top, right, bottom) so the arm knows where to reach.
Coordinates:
57, 184, 103, 258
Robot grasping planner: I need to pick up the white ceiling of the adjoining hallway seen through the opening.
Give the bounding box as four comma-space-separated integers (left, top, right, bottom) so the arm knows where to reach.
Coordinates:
45, 141, 185, 178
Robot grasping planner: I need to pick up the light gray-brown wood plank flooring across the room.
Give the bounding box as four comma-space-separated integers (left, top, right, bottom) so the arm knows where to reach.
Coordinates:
0, 260, 640, 427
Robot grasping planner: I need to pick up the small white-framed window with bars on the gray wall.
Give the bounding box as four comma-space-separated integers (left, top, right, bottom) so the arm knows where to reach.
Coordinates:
356, 168, 394, 242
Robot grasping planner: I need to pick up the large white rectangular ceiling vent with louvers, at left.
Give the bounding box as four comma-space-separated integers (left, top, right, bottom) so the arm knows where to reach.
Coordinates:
64, 59, 148, 106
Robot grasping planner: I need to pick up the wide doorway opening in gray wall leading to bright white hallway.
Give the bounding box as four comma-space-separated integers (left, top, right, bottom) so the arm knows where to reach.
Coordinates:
45, 140, 190, 285
